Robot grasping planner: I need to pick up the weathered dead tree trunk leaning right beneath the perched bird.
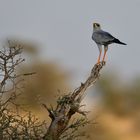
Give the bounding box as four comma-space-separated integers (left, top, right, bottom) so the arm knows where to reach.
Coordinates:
43, 62, 105, 140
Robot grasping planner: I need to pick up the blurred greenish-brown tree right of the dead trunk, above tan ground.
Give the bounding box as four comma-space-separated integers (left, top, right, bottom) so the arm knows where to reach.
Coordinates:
98, 74, 140, 116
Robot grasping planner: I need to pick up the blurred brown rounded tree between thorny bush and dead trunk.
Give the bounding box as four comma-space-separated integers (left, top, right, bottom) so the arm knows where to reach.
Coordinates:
19, 61, 69, 109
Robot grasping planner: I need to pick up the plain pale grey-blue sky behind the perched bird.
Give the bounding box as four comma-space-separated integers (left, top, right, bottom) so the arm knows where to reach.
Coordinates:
0, 0, 140, 84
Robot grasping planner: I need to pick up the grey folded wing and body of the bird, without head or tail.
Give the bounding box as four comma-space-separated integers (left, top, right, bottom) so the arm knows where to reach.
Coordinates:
92, 30, 115, 44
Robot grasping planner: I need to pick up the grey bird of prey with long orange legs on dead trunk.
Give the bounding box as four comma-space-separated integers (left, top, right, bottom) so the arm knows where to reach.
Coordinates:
92, 23, 127, 64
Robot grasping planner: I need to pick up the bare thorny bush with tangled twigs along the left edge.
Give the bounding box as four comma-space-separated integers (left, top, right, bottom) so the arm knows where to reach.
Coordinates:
0, 41, 46, 140
